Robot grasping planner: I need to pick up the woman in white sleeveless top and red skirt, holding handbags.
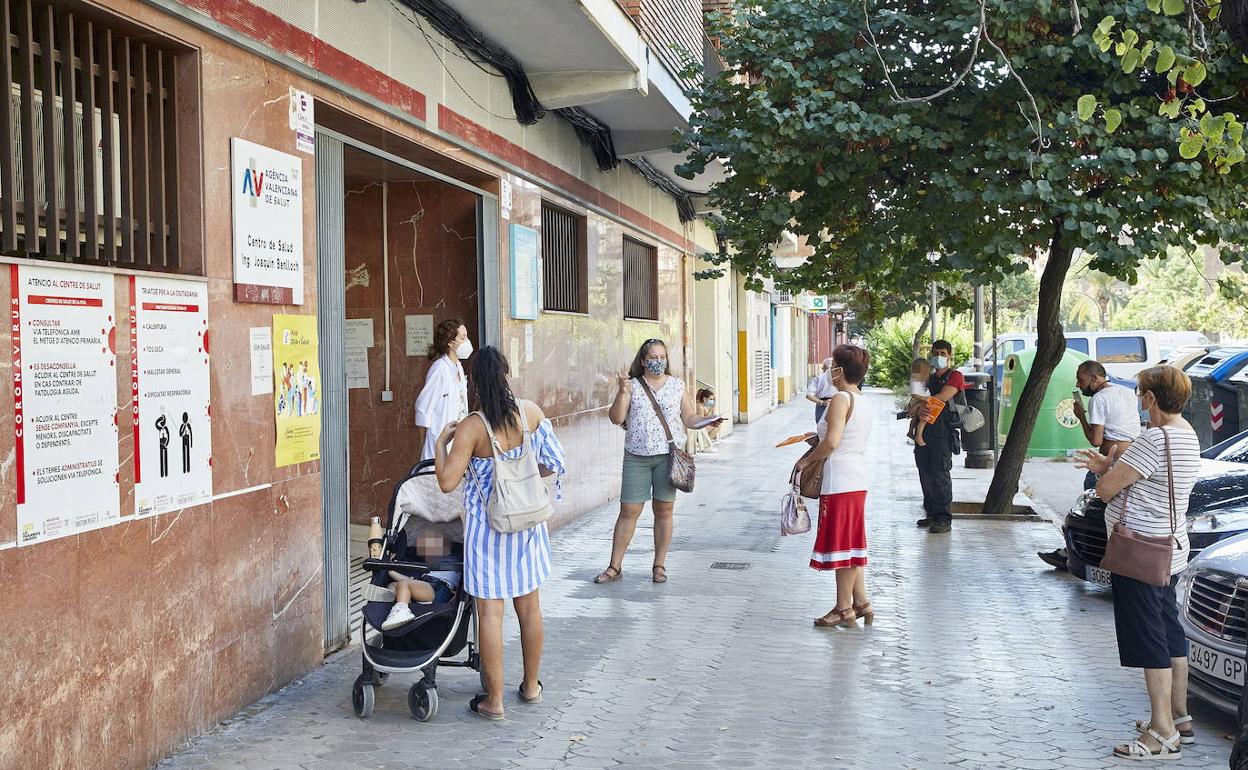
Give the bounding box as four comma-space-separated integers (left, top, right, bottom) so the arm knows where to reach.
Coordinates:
799, 344, 875, 628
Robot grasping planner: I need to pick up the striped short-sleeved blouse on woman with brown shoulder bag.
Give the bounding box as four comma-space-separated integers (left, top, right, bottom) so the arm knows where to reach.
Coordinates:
1104, 427, 1201, 575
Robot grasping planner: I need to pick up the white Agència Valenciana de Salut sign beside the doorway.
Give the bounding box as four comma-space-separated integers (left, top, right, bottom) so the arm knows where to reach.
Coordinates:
230, 137, 303, 305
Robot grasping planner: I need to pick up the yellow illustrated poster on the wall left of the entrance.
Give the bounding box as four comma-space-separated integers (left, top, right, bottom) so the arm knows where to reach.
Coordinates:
273, 316, 321, 468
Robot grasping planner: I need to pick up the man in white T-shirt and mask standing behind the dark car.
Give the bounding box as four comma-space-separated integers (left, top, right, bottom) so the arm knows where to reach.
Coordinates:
1037, 361, 1141, 569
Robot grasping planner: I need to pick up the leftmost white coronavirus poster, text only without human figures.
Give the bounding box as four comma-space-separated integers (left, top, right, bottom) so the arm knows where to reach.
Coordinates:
9, 265, 121, 545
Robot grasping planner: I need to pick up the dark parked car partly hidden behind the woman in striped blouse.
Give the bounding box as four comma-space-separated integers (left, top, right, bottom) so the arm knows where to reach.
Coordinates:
1062, 431, 1248, 585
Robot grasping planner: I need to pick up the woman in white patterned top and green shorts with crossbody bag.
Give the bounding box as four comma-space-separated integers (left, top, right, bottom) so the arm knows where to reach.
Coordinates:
594, 339, 724, 583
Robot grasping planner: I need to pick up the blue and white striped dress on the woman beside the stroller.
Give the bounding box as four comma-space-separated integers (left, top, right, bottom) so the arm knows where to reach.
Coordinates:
464, 419, 565, 599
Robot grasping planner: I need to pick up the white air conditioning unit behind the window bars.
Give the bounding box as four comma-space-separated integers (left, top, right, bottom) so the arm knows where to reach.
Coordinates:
9, 84, 121, 228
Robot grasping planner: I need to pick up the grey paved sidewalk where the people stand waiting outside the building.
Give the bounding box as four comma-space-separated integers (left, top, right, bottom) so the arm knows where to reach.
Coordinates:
158, 397, 1233, 770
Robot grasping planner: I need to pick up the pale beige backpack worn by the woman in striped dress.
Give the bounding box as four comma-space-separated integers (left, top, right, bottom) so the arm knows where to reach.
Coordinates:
473, 404, 554, 533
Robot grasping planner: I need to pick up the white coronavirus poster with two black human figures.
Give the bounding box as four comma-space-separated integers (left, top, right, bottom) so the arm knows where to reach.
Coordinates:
130, 276, 212, 517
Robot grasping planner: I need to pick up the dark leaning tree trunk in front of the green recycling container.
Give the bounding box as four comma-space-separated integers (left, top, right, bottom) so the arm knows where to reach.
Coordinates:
983, 220, 1075, 513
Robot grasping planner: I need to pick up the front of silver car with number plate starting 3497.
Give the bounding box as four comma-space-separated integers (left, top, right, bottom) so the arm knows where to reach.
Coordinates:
1178, 533, 1248, 714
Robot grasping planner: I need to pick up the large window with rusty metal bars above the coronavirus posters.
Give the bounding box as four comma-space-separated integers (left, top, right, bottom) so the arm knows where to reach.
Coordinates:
0, 0, 198, 272
